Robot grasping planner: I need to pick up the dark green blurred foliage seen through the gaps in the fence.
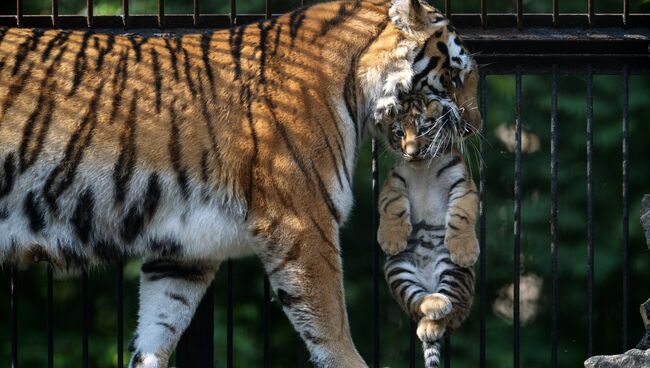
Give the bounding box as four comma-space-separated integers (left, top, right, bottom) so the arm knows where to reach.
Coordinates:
0, 0, 650, 368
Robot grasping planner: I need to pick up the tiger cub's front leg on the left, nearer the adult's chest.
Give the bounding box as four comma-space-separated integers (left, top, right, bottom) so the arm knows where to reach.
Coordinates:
377, 170, 413, 255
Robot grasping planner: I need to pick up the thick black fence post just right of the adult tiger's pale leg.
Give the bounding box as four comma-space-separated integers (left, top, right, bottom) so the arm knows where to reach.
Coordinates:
176, 286, 214, 368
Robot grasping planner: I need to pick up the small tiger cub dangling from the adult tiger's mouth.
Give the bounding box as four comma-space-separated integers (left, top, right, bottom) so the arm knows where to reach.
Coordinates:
378, 94, 479, 367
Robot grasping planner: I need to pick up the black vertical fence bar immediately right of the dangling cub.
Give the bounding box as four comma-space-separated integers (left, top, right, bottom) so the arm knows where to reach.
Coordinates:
479, 70, 487, 368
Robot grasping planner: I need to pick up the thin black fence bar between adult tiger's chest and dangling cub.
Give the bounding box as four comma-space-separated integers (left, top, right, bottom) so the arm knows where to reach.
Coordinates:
372, 138, 381, 368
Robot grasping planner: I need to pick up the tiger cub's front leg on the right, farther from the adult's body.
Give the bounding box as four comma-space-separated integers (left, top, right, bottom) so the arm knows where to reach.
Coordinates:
445, 176, 479, 267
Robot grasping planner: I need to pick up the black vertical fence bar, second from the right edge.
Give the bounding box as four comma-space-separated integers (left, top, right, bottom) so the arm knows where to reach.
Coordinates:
587, 64, 594, 357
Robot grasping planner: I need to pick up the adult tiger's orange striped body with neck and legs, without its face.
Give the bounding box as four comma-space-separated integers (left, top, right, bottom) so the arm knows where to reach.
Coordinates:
0, 0, 476, 367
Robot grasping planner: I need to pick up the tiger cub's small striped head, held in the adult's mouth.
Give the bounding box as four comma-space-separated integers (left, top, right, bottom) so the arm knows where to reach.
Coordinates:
387, 92, 471, 161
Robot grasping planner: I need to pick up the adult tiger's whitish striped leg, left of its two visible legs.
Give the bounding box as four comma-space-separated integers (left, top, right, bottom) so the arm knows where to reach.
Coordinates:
129, 259, 218, 368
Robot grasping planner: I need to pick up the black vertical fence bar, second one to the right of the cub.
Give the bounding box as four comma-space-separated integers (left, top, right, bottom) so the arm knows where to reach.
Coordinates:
512, 66, 521, 368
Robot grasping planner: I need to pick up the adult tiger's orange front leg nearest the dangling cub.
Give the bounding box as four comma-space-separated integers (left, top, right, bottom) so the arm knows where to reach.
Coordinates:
260, 221, 367, 368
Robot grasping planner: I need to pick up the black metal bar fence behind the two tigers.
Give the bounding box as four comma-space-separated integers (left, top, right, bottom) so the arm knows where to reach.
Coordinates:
0, 0, 650, 368
